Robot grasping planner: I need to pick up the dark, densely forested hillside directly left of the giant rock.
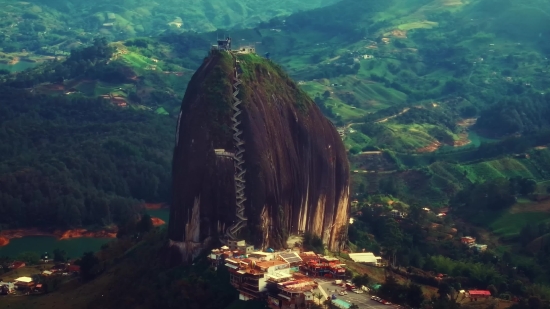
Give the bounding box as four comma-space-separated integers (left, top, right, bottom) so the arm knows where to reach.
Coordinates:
0, 86, 174, 228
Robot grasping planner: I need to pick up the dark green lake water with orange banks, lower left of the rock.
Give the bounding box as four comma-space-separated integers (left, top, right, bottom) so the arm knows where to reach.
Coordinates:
0, 209, 170, 258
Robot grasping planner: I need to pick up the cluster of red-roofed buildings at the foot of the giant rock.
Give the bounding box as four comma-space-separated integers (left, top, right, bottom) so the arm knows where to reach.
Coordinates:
208, 240, 345, 308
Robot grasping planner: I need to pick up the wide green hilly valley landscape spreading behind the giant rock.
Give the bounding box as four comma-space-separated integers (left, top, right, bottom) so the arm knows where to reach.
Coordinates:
0, 0, 550, 309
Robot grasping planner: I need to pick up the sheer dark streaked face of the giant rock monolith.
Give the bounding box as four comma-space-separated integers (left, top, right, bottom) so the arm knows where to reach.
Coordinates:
169, 51, 349, 264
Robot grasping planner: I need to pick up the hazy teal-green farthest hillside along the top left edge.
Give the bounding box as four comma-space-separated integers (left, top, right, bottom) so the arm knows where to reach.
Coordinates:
0, 0, 337, 53
